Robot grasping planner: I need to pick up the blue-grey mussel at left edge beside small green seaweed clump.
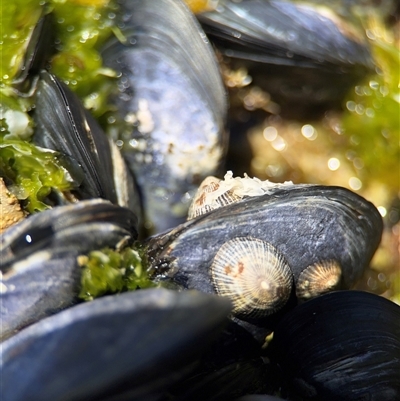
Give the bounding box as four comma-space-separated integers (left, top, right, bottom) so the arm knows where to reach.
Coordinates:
0, 200, 137, 339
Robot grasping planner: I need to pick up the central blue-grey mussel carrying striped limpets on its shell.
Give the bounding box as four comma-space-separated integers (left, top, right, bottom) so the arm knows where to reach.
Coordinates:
148, 174, 382, 334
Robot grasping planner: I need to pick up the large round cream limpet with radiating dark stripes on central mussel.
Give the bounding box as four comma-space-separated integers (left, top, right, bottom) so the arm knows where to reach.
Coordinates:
211, 237, 293, 318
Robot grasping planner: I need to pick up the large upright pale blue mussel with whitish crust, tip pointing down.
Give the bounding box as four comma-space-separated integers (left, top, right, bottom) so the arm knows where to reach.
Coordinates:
102, 0, 227, 233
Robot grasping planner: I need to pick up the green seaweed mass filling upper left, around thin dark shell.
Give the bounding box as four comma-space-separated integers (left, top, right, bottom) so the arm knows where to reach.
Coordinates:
0, 0, 116, 213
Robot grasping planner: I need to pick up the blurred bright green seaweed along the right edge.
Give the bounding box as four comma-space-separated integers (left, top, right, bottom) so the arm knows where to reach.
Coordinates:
342, 20, 400, 191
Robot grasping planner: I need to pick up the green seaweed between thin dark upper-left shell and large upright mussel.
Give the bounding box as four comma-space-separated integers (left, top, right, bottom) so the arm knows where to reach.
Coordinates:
50, 0, 117, 117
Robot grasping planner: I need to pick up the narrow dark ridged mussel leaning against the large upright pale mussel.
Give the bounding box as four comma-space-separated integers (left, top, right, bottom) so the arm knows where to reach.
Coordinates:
33, 71, 140, 216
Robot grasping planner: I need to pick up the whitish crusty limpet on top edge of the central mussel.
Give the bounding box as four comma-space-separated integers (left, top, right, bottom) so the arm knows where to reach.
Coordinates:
188, 171, 293, 220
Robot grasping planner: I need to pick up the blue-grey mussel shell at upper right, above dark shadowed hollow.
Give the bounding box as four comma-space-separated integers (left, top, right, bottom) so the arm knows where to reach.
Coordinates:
197, 0, 372, 67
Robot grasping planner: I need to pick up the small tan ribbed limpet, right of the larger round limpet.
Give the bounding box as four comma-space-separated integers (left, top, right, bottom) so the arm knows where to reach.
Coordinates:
296, 260, 342, 299
